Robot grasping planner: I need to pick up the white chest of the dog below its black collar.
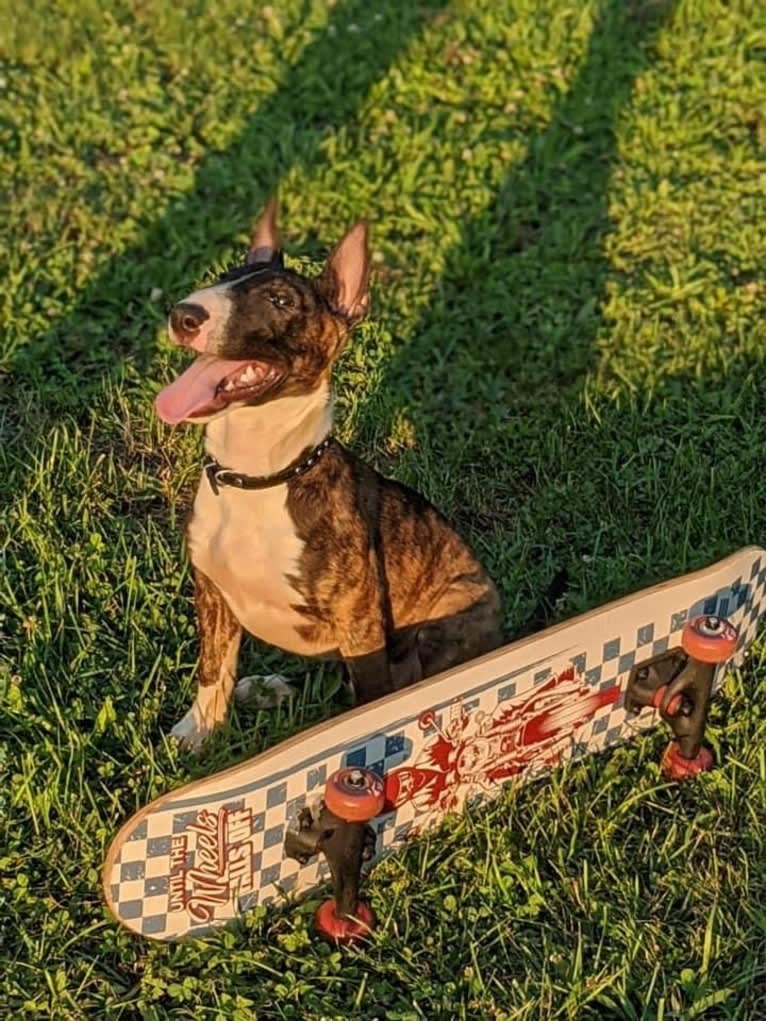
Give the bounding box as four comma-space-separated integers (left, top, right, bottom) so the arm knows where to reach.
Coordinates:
188, 479, 326, 654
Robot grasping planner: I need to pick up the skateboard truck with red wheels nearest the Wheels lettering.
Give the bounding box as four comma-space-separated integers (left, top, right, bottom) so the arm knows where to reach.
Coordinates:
285, 768, 385, 942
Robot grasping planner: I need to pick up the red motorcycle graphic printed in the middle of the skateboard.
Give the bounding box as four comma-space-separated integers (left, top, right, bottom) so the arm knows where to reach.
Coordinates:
386, 667, 620, 815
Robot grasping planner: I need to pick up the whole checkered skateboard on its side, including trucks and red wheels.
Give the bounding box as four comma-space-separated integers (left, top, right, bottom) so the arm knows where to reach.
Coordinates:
103, 547, 766, 940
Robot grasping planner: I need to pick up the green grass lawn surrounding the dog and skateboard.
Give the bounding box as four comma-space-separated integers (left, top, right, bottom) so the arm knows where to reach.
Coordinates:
0, 0, 766, 1021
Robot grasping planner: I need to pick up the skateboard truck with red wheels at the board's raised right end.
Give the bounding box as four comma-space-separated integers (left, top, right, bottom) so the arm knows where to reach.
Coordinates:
625, 615, 738, 780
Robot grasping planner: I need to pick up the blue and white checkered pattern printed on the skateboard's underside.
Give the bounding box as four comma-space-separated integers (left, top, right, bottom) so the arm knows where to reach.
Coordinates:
105, 555, 766, 938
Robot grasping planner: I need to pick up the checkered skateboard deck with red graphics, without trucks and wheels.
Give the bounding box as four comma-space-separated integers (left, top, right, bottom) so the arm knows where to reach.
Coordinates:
103, 547, 766, 939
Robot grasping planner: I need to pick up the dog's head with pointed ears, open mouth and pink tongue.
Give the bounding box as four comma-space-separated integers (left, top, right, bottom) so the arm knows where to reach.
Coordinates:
154, 199, 370, 425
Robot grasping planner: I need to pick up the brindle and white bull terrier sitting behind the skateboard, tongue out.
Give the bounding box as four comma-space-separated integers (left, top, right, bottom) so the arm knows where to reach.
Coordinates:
154, 200, 502, 748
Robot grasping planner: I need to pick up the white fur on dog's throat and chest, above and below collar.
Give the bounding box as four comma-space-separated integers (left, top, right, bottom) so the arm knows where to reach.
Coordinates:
188, 386, 332, 655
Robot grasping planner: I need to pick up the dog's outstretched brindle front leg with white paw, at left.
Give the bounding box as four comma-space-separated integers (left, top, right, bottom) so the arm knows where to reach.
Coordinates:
171, 570, 242, 748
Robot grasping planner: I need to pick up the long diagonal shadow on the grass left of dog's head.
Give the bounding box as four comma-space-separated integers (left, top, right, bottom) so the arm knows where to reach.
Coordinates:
8, 0, 444, 404
